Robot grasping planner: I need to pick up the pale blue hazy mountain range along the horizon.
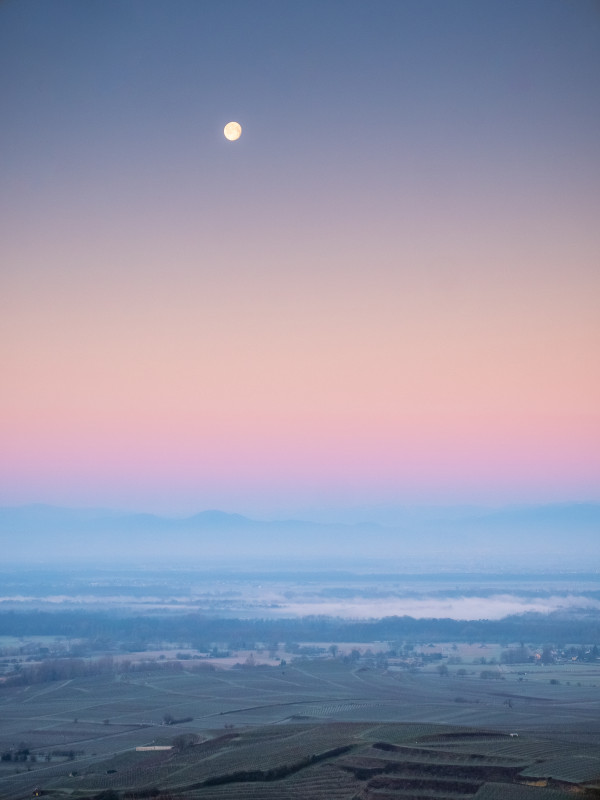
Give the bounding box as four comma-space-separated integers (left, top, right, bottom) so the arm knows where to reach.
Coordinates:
0, 503, 600, 571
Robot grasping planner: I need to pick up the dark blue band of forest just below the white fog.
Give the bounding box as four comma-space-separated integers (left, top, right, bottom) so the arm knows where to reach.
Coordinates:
0, 610, 600, 651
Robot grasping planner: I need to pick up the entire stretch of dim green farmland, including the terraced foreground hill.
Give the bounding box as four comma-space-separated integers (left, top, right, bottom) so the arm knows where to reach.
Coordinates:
0, 658, 600, 800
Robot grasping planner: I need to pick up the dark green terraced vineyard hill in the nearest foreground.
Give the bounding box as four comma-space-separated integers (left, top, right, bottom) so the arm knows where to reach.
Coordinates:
7, 722, 600, 800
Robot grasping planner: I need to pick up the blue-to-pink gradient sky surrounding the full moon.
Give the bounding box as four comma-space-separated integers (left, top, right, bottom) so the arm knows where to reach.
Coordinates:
0, 0, 600, 517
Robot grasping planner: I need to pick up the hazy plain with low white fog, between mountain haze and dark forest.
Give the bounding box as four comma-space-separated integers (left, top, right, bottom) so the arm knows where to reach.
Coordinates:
0, 569, 600, 620
